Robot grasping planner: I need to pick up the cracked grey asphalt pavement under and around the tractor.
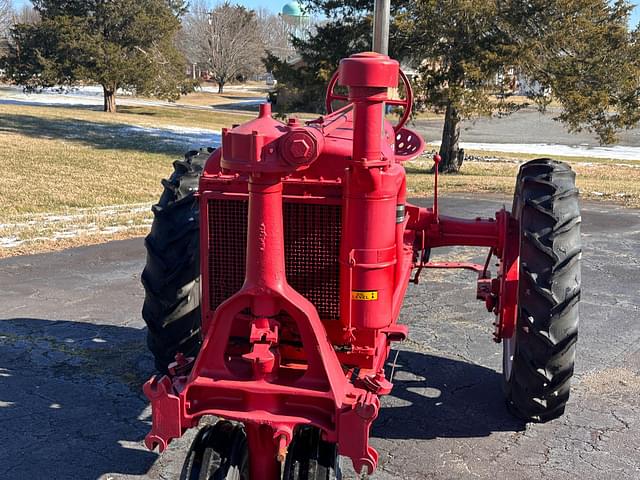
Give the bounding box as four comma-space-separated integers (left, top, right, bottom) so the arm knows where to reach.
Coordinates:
0, 197, 640, 480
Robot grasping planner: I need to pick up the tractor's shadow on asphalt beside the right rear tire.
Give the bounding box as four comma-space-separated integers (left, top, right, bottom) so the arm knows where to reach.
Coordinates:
373, 351, 525, 439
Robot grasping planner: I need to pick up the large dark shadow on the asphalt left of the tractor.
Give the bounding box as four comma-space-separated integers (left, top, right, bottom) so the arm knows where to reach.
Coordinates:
0, 318, 158, 480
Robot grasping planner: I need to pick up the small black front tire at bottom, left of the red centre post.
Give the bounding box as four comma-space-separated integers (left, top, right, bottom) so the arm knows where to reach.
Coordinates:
180, 420, 249, 480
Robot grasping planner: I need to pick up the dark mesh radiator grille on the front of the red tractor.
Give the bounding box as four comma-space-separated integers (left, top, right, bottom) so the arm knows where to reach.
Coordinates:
208, 200, 342, 320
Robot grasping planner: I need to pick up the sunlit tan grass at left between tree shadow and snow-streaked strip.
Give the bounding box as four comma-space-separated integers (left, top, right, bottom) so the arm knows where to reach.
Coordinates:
0, 134, 168, 218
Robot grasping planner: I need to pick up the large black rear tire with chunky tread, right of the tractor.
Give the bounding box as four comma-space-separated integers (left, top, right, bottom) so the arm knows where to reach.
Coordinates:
503, 158, 582, 422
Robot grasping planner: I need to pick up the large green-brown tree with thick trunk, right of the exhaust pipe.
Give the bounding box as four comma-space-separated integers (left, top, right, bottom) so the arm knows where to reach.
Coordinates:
402, 0, 640, 172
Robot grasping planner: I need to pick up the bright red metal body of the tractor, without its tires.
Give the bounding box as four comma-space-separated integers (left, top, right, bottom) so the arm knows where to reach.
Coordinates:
144, 53, 518, 480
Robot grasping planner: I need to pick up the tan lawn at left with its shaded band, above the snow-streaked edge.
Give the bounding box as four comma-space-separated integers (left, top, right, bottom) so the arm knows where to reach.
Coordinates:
0, 105, 250, 218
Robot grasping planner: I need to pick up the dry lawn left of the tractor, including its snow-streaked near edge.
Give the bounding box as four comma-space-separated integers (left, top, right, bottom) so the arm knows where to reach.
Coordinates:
0, 105, 245, 257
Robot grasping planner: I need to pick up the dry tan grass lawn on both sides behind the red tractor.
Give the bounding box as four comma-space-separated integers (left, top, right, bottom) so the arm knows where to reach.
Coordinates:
0, 105, 640, 257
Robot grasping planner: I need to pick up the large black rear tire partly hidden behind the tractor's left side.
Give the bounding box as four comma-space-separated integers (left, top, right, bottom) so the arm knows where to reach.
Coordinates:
142, 149, 212, 373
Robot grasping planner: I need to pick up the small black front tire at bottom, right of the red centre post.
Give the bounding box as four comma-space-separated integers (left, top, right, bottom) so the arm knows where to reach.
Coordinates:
282, 426, 342, 480
